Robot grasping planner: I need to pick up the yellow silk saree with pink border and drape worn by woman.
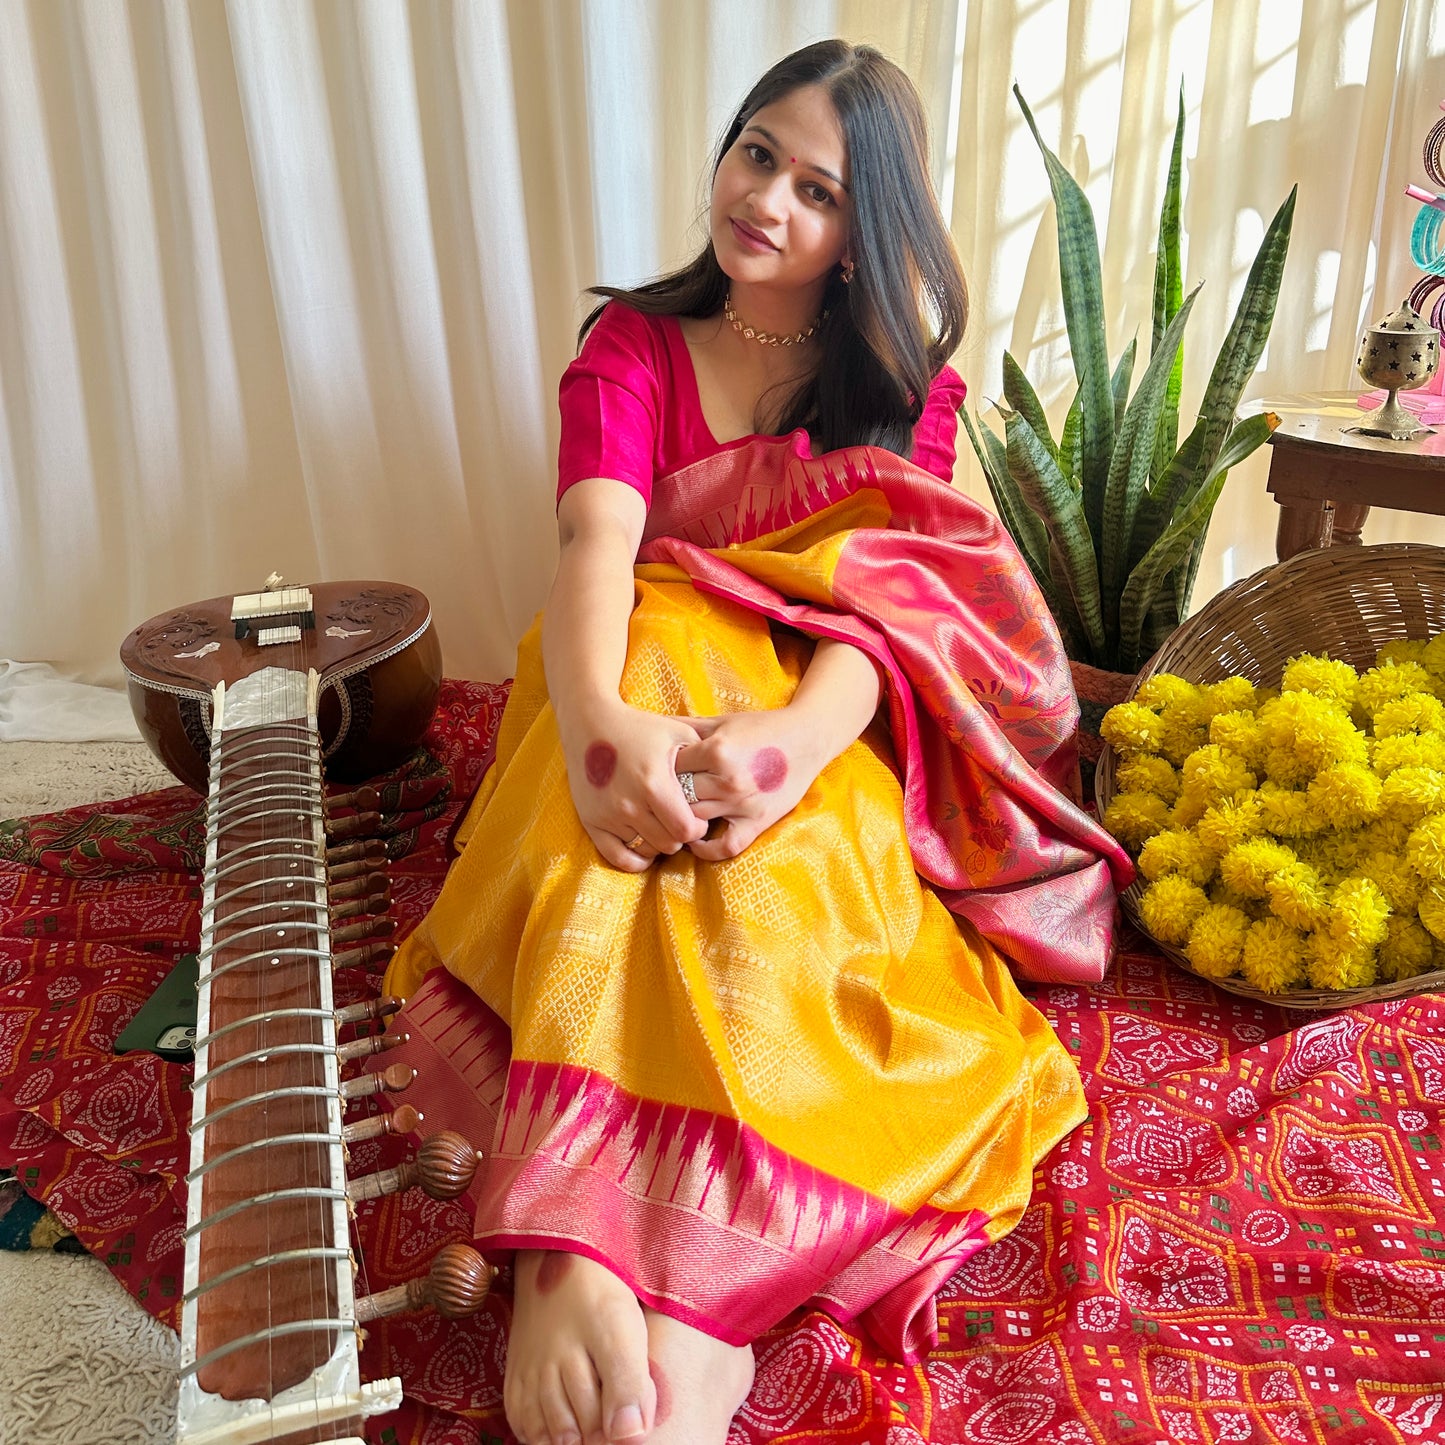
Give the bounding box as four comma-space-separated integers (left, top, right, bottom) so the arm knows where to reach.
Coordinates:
386, 434, 1129, 1358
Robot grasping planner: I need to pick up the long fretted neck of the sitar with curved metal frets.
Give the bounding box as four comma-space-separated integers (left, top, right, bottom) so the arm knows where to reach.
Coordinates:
178, 666, 400, 1445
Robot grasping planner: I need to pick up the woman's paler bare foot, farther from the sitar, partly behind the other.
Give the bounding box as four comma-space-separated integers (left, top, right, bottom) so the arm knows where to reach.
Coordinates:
643, 1306, 753, 1445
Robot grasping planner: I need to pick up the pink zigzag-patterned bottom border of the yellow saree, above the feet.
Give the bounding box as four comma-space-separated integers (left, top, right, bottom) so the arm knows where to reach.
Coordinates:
373, 970, 987, 1360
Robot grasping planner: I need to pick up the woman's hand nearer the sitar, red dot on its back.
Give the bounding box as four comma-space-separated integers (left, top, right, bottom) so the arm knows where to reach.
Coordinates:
562, 699, 707, 873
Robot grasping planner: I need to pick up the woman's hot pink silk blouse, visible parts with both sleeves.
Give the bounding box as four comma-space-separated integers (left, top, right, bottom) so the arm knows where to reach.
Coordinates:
556, 301, 964, 503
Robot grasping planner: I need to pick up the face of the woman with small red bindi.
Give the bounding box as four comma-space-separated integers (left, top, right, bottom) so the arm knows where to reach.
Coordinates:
711, 85, 851, 297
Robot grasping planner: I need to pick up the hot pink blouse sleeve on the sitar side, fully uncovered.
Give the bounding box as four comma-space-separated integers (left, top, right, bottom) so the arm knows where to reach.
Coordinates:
556, 301, 662, 503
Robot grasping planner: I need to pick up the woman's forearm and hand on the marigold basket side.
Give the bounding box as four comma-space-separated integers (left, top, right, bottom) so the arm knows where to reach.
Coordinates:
676, 637, 880, 861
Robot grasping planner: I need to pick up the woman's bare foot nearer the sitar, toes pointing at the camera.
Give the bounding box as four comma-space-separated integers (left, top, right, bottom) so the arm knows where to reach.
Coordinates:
503, 1250, 656, 1445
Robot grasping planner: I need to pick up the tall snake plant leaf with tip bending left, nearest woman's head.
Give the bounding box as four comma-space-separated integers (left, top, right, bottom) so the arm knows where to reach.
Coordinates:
1013, 85, 1114, 545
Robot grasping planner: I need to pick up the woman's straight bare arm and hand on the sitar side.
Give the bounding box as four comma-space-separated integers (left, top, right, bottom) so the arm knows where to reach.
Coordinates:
542, 477, 705, 873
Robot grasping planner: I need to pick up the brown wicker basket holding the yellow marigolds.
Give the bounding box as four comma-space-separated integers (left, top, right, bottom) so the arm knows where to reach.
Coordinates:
1095, 543, 1445, 1009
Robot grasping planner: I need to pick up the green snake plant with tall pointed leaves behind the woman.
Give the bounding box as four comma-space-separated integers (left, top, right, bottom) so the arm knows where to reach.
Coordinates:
964, 85, 1298, 672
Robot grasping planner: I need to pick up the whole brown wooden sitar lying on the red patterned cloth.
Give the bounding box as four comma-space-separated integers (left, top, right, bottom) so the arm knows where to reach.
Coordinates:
121, 575, 494, 1445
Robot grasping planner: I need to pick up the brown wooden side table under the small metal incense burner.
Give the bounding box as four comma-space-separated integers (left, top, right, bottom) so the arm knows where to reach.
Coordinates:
1247, 387, 1445, 562
